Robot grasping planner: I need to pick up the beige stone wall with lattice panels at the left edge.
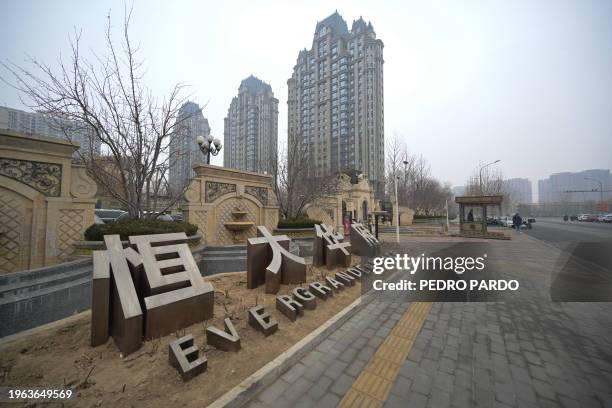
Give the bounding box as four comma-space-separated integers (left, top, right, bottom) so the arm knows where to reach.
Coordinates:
0, 130, 96, 274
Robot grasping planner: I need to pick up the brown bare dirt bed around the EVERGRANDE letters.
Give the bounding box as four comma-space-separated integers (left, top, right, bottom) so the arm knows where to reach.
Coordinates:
0, 255, 361, 407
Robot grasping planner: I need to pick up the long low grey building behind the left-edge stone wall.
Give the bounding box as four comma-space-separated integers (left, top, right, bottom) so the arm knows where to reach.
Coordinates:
0, 106, 101, 158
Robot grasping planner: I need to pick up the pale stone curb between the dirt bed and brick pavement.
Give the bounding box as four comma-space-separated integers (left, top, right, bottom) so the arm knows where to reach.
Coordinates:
208, 271, 399, 408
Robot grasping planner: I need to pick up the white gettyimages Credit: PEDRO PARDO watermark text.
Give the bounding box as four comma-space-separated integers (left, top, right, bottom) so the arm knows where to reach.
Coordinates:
372, 254, 520, 291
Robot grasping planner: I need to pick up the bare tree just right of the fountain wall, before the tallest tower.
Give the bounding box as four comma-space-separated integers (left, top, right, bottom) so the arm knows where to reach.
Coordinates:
274, 142, 340, 219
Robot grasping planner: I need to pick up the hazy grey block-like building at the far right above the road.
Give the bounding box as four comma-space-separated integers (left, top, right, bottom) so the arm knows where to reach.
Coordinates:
538, 169, 612, 203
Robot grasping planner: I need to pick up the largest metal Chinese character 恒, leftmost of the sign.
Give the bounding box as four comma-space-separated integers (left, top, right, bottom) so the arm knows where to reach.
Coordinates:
91, 232, 214, 355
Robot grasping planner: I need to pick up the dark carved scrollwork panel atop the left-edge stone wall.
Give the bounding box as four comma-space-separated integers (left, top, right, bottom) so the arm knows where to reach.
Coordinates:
0, 157, 62, 197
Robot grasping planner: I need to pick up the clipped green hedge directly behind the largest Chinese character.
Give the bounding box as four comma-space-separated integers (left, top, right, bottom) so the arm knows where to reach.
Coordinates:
85, 220, 198, 241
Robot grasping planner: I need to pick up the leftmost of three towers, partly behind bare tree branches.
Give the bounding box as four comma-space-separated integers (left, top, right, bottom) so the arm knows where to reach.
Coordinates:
169, 102, 210, 194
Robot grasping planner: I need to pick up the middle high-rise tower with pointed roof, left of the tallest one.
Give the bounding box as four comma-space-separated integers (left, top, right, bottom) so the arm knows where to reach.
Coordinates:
223, 75, 278, 174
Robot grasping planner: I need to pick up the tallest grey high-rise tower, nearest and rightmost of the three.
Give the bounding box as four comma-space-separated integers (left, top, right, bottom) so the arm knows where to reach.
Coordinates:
287, 12, 385, 197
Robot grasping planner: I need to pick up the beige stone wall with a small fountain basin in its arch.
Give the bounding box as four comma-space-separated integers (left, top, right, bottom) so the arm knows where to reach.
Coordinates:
182, 164, 278, 245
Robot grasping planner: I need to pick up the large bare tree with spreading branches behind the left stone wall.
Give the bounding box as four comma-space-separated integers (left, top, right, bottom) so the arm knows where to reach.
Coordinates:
1, 9, 197, 217
